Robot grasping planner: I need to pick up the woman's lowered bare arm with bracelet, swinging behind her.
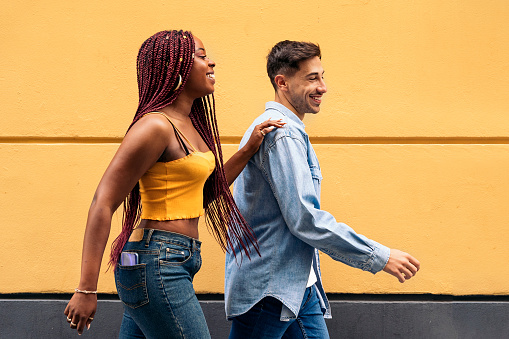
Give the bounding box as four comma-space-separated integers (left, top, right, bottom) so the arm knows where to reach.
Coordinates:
64, 117, 170, 333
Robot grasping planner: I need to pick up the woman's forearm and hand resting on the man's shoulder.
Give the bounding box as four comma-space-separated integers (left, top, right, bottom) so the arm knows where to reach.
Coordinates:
224, 119, 285, 185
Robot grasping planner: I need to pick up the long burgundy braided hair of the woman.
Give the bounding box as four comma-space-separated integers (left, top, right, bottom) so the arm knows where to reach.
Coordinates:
109, 30, 260, 266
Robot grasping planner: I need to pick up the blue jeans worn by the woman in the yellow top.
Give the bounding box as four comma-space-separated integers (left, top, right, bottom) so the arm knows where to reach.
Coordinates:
115, 229, 210, 339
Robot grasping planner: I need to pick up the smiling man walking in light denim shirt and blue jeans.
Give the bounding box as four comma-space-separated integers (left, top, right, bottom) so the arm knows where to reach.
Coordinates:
225, 41, 420, 339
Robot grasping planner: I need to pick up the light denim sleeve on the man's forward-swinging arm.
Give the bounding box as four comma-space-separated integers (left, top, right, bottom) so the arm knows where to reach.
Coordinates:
261, 135, 390, 273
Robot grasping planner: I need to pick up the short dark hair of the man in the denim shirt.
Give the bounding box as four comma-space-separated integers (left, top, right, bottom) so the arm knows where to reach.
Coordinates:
267, 40, 322, 90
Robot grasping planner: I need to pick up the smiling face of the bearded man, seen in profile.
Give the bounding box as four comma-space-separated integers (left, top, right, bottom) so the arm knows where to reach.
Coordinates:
283, 57, 327, 118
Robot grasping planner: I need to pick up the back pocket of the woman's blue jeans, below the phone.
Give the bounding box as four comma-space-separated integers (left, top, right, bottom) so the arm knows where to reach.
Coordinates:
115, 264, 148, 308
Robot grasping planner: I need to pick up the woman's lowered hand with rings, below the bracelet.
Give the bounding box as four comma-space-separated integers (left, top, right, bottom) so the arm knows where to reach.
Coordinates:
64, 293, 97, 335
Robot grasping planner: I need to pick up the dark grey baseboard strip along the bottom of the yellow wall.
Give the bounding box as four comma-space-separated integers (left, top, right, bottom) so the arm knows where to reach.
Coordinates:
0, 295, 509, 339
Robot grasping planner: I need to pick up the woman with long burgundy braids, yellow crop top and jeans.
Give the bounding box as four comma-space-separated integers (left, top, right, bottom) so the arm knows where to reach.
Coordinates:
64, 31, 283, 338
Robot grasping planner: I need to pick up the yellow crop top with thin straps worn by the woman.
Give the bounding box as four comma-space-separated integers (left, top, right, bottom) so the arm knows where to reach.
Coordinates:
139, 112, 216, 220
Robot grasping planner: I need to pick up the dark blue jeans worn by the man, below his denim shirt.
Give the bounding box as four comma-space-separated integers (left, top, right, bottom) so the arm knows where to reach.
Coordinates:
229, 286, 329, 339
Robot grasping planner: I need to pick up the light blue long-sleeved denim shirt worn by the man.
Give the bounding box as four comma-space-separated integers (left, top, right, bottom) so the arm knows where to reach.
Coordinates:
225, 101, 390, 320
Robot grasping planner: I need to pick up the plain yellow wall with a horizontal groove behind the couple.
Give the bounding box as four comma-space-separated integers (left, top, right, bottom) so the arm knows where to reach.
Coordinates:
0, 0, 509, 295
